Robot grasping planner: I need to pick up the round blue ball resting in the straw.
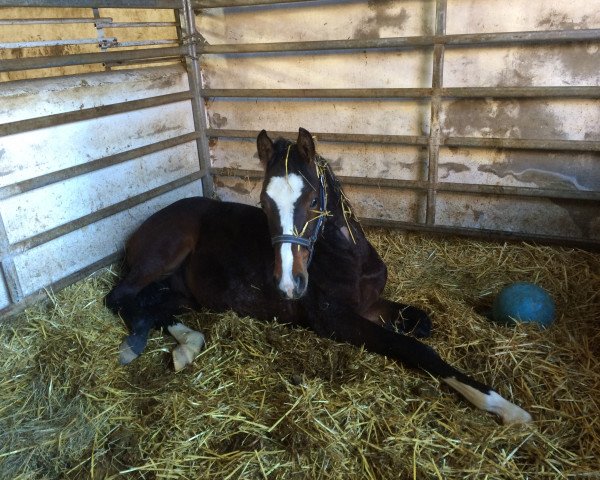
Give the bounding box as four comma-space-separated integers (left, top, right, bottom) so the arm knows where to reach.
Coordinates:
492, 282, 556, 328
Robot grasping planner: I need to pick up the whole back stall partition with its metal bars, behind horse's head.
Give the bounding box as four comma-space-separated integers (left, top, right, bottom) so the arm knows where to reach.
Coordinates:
197, 0, 600, 251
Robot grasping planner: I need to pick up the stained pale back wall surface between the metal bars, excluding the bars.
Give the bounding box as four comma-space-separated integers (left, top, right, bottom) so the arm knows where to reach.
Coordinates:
197, 0, 600, 242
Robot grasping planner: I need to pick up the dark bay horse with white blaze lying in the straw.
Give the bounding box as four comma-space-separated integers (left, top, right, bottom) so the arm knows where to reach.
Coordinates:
106, 128, 531, 423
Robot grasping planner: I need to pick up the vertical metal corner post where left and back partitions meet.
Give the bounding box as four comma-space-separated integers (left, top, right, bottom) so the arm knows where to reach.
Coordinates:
179, 0, 214, 197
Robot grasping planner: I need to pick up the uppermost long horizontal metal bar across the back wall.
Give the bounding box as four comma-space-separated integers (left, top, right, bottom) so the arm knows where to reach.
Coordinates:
199, 29, 600, 54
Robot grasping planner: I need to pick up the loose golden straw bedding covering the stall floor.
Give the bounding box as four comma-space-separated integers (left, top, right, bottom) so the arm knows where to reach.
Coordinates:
0, 230, 600, 479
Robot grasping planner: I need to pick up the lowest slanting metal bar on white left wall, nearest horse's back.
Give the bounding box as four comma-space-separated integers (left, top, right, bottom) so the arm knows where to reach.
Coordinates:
9, 172, 204, 255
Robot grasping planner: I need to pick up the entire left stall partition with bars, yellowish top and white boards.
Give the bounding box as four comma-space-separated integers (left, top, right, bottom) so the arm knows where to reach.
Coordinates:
0, 0, 211, 318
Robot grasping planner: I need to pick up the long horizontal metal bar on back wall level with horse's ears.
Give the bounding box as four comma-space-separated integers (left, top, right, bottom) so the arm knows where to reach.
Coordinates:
207, 128, 600, 152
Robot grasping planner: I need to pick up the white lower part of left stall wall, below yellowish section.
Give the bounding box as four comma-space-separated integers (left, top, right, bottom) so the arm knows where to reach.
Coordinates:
0, 65, 202, 312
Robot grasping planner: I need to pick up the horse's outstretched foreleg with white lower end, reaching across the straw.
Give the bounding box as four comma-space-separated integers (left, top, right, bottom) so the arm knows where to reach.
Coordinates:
315, 311, 531, 424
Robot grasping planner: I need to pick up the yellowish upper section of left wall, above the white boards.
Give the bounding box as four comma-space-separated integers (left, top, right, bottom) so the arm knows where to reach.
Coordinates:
0, 5, 178, 81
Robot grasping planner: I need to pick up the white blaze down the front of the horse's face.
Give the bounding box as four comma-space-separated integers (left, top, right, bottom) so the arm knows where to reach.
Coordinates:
266, 173, 304, 298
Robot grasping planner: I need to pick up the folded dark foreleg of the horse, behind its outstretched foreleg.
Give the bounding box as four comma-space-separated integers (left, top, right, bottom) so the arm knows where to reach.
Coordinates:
360, 298, 431, 338
